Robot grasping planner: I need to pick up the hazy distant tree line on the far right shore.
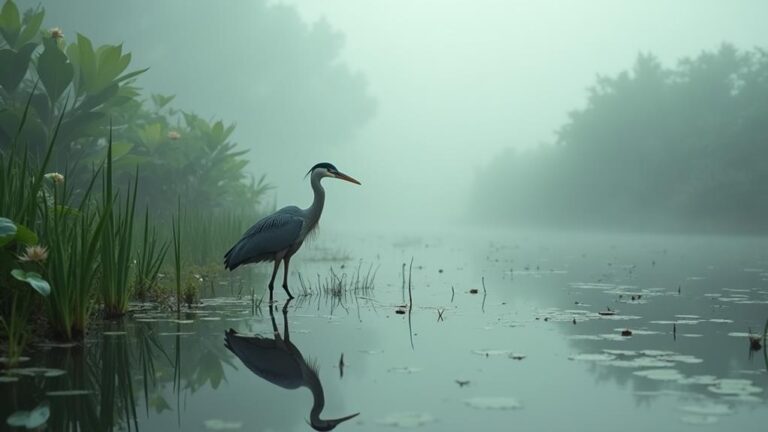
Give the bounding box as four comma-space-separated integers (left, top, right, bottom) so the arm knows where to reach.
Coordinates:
473, 45, 768, 233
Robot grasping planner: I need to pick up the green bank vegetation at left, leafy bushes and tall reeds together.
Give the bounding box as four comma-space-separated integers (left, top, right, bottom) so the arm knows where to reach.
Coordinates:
0, 0, 269, 363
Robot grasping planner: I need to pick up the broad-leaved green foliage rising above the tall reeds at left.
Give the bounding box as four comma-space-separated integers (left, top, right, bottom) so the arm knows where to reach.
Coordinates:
0, 1, 267, 214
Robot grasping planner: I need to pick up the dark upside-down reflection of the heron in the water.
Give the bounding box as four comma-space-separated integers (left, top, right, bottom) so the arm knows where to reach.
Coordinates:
220, 300, 360, 431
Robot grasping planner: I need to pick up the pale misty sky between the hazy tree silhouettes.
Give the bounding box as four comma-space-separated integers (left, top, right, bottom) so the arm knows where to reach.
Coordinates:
282, 0, 768, 231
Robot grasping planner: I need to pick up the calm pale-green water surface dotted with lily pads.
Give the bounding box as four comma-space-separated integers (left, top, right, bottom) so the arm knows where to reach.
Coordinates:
0, 231, 768, 431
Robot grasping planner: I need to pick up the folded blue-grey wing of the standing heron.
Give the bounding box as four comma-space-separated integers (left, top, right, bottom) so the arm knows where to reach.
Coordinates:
224, 207, 304, 270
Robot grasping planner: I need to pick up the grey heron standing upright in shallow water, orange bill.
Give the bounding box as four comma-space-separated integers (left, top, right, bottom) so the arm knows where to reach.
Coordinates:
224, 162, 360, 301
